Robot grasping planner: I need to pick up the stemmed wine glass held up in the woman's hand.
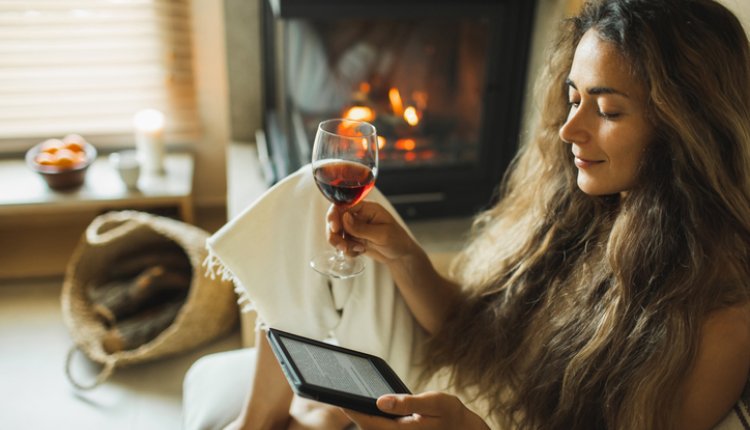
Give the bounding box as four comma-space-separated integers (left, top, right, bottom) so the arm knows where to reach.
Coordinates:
310, 119, 378, 279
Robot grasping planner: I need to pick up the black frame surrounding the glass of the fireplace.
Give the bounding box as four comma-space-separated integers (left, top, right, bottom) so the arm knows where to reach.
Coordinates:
257, 0, 536, 219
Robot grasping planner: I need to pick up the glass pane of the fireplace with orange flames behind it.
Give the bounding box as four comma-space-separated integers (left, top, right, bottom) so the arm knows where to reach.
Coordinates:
283, 18, 489, 170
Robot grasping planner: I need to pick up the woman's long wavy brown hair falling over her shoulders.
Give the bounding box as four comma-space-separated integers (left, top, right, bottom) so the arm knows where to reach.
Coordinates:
427, 0, 750, 430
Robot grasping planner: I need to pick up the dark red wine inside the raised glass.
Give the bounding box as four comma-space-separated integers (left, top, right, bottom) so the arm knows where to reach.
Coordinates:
313, 160, 375, 206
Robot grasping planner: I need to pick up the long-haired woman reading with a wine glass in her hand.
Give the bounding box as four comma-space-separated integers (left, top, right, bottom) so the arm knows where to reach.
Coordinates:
198, 0, 750, 429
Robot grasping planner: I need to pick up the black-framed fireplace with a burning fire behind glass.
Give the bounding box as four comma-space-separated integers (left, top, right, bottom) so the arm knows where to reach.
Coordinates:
258, 0, 534, 218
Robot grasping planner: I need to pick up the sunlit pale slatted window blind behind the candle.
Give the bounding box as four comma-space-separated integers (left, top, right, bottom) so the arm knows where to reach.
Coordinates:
0, 0, 198, 151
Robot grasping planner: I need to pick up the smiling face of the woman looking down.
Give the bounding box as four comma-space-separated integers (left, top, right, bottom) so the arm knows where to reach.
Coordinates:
560, 30, 653, 195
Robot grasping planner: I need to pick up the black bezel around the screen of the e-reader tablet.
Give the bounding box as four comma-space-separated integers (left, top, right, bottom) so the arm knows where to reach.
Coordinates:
267, 328, 411, 418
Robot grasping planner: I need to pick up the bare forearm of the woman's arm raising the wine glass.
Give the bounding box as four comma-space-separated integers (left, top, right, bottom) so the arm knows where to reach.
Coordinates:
388, 244, 462, 334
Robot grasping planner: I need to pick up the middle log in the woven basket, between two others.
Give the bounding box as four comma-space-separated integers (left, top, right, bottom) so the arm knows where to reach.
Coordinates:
92, 266, 191, 325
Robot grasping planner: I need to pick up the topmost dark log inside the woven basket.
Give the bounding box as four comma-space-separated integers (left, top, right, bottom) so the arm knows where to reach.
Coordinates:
108, 246, 192, 279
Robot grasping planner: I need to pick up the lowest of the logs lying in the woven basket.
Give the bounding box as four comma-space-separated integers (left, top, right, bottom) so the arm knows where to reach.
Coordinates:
102, 301, 184, 354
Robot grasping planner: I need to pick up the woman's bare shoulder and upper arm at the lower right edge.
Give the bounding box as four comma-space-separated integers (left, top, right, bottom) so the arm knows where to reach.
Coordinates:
679, 304, 750, 429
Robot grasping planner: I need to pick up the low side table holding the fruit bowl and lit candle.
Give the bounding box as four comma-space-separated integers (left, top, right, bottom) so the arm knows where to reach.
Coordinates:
0, 153, 195, 223
